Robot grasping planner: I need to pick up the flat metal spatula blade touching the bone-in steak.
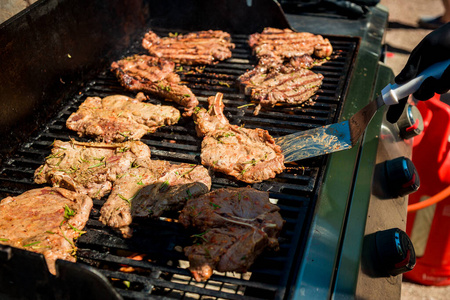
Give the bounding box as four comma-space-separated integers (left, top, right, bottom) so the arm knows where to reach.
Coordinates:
276, 121, 352, 162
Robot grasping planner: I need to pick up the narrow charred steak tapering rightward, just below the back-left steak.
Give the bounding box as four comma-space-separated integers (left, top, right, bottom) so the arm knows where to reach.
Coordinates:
111, 55, 198, 116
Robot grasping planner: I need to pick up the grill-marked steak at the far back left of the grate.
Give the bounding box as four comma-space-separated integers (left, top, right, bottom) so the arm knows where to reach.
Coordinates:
142, 30, 235, 65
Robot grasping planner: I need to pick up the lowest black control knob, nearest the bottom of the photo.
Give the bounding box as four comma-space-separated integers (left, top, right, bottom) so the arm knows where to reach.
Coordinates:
375, 228, 416, 276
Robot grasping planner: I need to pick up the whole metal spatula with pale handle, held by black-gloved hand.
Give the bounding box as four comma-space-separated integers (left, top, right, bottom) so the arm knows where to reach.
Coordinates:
275, 59, 450, 162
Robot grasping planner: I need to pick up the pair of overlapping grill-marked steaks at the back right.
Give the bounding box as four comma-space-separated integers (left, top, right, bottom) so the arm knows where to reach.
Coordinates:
238, 28, 333, 115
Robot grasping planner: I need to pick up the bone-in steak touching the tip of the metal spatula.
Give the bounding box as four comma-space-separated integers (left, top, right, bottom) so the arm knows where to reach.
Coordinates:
194, 93, 285, 183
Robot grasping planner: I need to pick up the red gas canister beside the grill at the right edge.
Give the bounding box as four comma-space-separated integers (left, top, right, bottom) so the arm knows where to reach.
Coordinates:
404, 95, 450, 285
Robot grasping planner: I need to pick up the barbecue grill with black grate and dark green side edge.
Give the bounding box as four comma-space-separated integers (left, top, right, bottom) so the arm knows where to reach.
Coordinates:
0, 0, 418, 299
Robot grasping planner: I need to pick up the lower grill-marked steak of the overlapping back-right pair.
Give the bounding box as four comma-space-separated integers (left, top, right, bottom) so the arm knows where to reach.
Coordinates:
238, 59, 323, 115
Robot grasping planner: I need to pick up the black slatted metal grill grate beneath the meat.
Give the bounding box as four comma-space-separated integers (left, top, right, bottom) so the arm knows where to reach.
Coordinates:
0, 29, 358, 299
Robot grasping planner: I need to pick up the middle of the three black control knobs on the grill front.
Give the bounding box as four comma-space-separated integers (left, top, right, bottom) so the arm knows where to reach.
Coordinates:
385, 156, 420, 197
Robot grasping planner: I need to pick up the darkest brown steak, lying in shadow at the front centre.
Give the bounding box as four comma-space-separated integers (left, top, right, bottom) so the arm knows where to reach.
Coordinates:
179, 187, 284, 281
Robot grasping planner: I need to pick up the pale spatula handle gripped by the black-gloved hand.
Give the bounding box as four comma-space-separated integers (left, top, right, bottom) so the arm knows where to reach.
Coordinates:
381, 59, 450, 105
